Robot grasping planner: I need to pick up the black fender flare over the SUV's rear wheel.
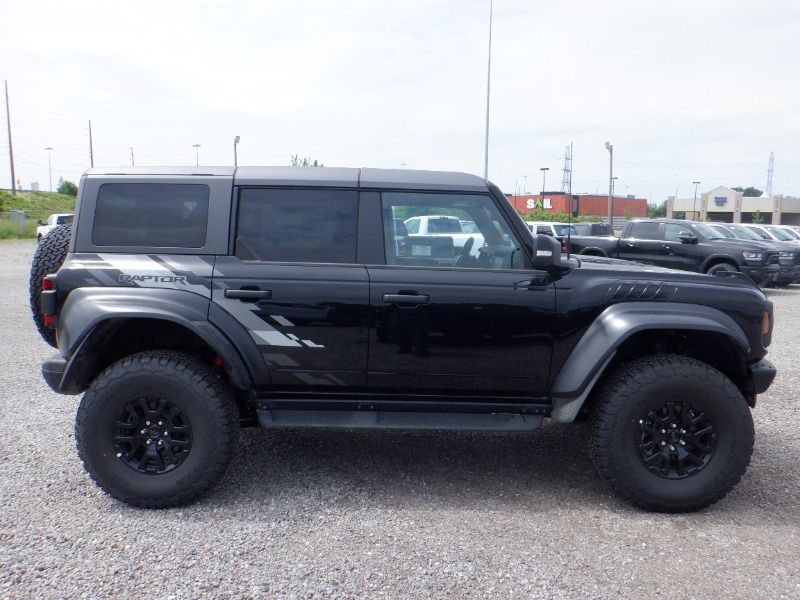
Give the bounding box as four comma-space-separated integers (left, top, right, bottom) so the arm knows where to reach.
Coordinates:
58, 287, 253, 393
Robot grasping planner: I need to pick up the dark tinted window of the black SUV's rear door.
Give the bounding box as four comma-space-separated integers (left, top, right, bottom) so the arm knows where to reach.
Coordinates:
236, 189, 358, 263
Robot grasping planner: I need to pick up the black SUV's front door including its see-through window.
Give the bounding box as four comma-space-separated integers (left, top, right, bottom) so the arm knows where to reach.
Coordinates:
367, 193, 555, 396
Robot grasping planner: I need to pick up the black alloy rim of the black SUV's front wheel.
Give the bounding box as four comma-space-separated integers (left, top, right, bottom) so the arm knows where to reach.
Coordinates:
635, 400, 717, 479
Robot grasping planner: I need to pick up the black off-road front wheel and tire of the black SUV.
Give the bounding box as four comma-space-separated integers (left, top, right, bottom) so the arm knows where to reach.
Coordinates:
589, 354, 755, 512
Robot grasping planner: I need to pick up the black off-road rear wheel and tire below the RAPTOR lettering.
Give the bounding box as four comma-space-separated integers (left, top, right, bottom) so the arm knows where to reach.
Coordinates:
75, 350, 239, 508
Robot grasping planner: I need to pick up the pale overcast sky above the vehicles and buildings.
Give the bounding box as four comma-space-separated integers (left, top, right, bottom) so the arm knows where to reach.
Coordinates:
0, 0, 800, 202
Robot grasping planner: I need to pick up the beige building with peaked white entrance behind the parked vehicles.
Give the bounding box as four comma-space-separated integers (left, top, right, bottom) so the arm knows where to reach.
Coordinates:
664, 185, 800, 225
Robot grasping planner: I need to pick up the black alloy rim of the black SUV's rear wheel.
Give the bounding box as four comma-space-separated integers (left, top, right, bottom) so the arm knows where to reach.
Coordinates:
113, 397, 192, 475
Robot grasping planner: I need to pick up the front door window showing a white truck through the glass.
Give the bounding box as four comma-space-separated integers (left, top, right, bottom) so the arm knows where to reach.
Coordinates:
382, 192, 528, 269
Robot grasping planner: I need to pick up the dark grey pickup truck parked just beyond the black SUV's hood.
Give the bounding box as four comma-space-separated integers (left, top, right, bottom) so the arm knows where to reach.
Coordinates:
570, 219, 780, 284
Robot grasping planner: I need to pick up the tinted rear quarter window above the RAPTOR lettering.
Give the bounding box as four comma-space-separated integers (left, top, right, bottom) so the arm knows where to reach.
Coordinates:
92, 183, 209, 248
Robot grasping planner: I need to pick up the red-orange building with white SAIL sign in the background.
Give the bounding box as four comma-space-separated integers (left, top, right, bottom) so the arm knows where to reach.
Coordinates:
506, 192, 647, 219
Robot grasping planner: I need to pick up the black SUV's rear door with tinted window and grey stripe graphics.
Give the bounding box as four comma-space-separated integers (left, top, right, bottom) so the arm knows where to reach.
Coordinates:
212, 188, 369, 392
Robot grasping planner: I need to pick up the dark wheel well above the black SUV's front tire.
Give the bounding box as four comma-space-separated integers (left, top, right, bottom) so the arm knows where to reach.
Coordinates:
595, 329, 754, 405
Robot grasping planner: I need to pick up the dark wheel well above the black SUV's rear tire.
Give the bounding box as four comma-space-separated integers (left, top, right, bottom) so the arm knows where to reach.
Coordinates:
70, 318, 258, 419
